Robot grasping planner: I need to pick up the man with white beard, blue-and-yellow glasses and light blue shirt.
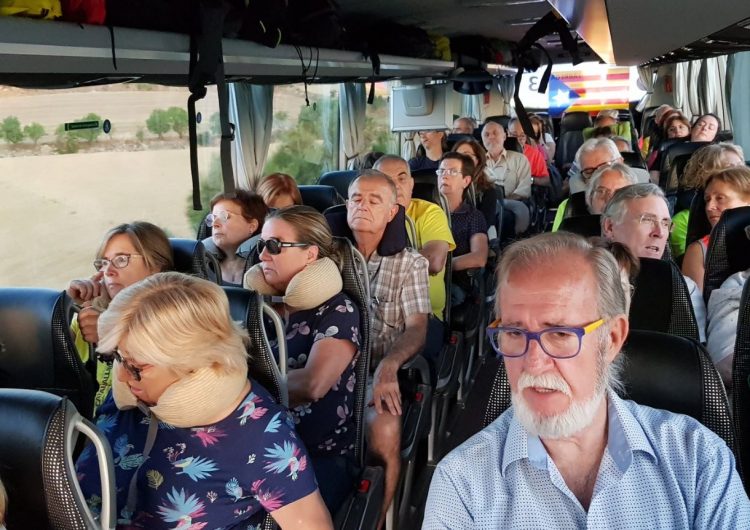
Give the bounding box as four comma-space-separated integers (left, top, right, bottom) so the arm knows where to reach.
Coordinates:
423, 233, 750, 530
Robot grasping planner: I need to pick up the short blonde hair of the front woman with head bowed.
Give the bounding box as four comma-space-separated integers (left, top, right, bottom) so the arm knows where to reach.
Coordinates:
97, 272, 250, 374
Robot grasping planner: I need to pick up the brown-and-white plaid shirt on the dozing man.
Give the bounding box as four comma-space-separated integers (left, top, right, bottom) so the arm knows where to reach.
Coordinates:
367, 248, 432, 371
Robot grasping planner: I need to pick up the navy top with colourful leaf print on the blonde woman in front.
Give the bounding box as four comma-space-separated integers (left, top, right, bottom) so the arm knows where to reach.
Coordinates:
76, 380, 317, 530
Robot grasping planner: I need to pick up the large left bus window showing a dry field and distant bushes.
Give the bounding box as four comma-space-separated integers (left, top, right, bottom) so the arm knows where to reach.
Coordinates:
0, 84, 220, 289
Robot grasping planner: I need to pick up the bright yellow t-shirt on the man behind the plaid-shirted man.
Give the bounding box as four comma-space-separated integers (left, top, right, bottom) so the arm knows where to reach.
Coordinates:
406, 199, 456, 320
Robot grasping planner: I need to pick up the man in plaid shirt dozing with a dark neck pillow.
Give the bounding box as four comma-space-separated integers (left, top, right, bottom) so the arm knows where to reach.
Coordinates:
346, 170, 432, 527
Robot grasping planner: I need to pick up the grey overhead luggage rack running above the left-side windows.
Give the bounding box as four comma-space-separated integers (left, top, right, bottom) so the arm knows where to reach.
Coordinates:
0, 17, 454, 86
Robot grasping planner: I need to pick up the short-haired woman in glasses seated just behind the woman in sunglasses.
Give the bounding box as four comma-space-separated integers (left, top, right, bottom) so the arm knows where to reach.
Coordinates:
203, 190, 268, 287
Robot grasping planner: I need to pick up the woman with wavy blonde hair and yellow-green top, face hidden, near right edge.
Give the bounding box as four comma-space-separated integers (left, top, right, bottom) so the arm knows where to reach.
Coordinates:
669, 142, 745, 257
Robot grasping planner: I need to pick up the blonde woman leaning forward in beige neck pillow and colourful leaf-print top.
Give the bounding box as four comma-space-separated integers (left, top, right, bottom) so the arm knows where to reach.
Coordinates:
77, 272, 332, 530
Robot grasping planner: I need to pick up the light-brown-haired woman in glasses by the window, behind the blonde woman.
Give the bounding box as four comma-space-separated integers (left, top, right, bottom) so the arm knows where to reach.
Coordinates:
67, 221, 174, 407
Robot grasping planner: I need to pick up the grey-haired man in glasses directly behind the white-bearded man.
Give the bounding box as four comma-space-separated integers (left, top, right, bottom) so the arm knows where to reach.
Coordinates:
601, 182, 706, 342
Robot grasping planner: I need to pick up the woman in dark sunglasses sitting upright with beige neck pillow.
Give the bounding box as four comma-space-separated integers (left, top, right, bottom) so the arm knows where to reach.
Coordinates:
245, 206, 364, 513
